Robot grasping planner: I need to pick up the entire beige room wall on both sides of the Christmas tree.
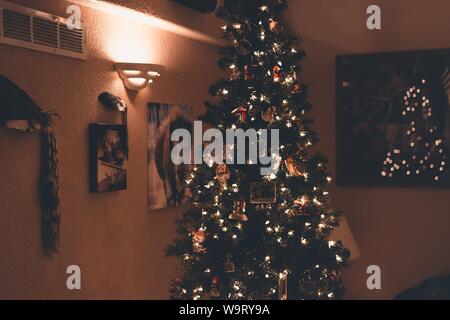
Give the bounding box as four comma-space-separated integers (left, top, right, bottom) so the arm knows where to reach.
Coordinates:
0, 0, 450, 299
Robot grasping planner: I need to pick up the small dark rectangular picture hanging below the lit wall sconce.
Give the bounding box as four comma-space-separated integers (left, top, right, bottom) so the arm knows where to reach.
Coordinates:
89, 123, 128, 193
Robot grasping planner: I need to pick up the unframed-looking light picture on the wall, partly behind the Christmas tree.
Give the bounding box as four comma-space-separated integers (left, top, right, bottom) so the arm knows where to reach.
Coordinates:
148, 103, 192, 210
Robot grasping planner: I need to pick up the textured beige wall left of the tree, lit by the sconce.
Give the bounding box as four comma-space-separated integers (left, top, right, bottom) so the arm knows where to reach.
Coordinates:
0, 0, 220, 299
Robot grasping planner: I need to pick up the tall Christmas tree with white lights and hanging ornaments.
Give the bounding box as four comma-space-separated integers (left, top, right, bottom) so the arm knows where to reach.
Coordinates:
167, 0, 349, 300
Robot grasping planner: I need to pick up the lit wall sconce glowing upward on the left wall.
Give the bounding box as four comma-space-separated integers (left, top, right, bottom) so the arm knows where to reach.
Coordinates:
114, 63, 164, 91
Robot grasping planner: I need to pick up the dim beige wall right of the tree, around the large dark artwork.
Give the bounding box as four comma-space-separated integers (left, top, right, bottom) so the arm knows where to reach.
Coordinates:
287, 0, 450, 299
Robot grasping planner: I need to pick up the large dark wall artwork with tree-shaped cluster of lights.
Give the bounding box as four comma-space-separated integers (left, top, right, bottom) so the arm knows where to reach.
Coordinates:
336, 49, 450, 187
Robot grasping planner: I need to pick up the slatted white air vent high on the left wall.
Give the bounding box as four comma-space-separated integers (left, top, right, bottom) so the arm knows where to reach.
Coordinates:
0, 0, 86, 59
